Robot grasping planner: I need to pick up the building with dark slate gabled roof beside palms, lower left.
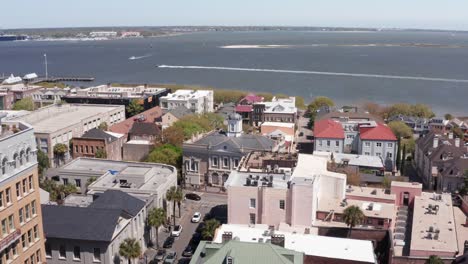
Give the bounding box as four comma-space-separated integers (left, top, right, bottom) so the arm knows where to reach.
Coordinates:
42, 190, 149, 264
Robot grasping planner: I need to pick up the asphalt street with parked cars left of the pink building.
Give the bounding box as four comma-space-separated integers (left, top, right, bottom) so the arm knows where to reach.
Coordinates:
144, 192, 227, 263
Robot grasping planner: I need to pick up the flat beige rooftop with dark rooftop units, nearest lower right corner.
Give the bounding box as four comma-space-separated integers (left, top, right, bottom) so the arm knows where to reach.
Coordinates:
410, 192, 458, 255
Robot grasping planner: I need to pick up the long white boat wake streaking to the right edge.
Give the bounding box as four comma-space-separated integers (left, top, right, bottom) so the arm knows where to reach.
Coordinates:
156, 65, 468, 83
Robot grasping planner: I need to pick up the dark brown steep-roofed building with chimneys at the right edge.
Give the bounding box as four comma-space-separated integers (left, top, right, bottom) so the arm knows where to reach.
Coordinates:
414, 132, 468, 192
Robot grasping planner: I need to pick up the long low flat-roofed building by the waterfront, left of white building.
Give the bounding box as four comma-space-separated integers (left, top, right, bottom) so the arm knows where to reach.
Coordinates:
62, 85, 170, 118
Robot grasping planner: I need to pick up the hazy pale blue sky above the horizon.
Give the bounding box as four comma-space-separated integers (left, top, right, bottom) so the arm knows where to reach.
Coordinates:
0, 0, 468, 30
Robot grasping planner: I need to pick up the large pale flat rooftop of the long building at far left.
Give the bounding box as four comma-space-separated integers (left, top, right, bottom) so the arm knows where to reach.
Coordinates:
9, 104, 124, 133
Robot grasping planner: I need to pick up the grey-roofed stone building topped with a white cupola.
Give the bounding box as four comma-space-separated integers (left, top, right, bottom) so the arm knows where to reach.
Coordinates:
182, 114, 276, 186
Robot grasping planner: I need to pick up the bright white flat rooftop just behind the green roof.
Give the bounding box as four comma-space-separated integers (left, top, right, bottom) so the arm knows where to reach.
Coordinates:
213, 225, 376, 263
